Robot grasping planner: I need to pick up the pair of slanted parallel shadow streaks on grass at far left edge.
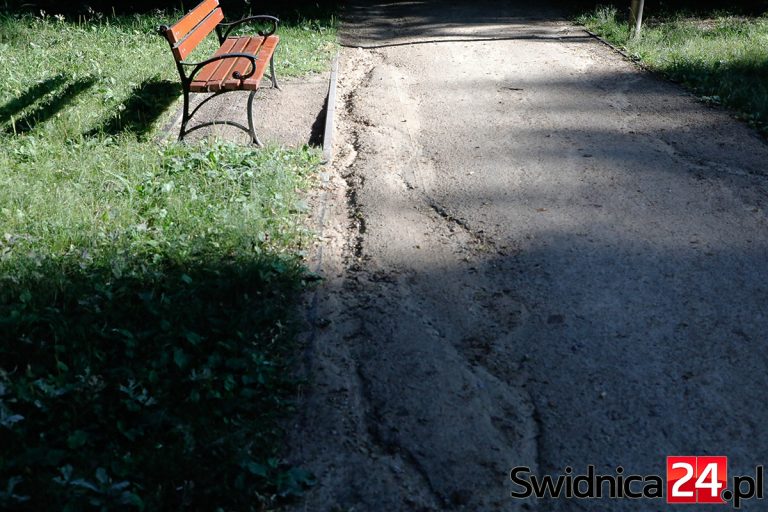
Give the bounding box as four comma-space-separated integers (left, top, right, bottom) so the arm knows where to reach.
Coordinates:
0, 75, 96, 135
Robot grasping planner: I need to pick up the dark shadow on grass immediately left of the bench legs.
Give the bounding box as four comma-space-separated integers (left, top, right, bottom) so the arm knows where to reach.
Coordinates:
86, 80, 181, 138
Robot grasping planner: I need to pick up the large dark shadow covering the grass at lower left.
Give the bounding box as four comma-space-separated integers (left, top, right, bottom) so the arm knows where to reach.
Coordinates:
0, 255, 312, 510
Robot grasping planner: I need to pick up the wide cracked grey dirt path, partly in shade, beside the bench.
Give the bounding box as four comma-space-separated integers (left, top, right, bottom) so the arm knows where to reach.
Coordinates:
290, 0, 768, 512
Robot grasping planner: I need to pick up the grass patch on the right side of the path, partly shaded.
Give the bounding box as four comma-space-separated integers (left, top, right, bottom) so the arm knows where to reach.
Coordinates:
578, 7, 768, 133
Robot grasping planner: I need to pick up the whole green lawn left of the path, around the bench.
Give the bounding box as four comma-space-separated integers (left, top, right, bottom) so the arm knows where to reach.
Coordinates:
0, 9, 335, 511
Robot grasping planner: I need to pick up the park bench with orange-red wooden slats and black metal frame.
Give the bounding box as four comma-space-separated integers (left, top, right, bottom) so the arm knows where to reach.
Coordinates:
158, 0, 280, 146
